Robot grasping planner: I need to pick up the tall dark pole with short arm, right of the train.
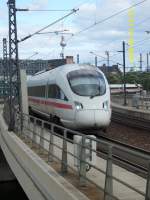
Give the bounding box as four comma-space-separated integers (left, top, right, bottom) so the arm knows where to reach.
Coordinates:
118, 41, 127, 106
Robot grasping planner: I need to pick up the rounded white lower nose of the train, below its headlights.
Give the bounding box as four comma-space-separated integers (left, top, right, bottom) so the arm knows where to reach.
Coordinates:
76, 110, 110, 128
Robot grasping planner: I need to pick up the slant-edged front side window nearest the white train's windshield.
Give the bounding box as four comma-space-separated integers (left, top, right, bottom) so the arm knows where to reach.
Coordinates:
48, 84, 68, 101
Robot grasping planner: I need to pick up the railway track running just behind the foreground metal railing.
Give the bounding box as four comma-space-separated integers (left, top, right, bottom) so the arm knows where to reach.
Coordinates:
29, 111, 150, 177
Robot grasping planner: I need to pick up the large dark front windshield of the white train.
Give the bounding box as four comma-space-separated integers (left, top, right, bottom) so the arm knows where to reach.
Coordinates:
67, 69, 106, 98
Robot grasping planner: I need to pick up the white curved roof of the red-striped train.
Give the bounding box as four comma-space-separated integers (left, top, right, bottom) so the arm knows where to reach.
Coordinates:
27, 64, 101, 86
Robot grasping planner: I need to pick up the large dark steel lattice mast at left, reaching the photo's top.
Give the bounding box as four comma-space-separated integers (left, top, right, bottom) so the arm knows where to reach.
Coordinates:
8, 0, 22, 131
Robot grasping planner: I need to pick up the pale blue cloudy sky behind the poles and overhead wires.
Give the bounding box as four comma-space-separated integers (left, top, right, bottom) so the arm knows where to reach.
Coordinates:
0, 0, 150, 70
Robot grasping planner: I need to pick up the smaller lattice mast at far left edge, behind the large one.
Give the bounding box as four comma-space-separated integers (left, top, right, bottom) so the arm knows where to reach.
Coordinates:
3, 38, 8, 99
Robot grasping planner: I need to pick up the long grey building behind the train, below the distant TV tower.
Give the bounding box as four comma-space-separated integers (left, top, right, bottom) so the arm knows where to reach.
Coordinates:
0, 56, 74, 76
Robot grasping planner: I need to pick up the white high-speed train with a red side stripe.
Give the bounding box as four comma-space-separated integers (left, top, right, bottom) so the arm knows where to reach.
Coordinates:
27, 64, 111, 129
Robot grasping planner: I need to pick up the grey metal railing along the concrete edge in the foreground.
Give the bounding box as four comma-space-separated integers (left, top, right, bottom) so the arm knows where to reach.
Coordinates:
15, 114, 150, 200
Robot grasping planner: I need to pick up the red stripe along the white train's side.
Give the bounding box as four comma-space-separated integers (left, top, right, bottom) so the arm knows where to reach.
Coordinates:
28, 97, 72, 109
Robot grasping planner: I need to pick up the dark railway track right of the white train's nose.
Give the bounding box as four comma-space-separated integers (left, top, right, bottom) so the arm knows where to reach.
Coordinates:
112, 110, 150, 130
